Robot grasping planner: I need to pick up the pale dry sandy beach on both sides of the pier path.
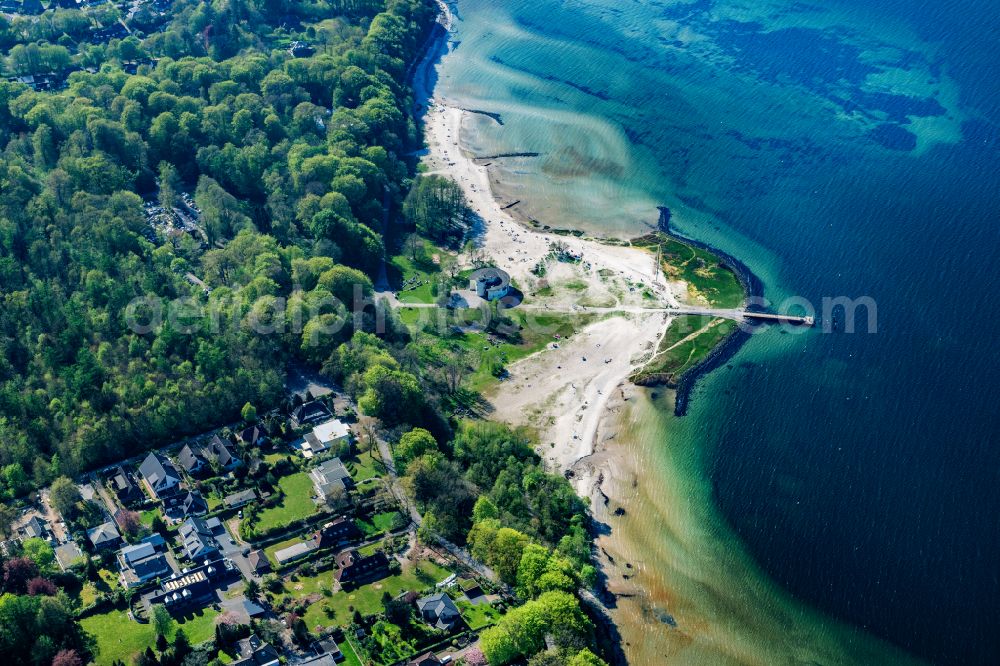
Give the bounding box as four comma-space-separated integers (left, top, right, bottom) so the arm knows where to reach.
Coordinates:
425, 98, 686, 474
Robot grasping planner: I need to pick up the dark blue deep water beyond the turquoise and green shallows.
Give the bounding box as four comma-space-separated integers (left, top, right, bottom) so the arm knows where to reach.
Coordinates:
692, 2, 1000, 664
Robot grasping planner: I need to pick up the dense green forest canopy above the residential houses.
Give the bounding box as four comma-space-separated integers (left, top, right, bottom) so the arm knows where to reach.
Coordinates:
0, 0, 435, 497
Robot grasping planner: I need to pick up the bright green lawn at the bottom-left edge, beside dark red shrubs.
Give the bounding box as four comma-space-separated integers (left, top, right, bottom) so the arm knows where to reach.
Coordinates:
80, 608, 219, 665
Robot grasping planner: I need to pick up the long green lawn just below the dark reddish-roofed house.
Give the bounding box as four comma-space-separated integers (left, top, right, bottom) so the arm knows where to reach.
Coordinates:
285, 560, 451, 631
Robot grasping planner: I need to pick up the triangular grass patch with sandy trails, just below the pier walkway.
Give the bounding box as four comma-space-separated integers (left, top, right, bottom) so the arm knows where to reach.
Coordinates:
632, 315, 736, 386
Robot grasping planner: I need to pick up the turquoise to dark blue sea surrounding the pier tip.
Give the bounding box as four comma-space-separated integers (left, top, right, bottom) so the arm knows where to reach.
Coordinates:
436, 0, 1000, 664
